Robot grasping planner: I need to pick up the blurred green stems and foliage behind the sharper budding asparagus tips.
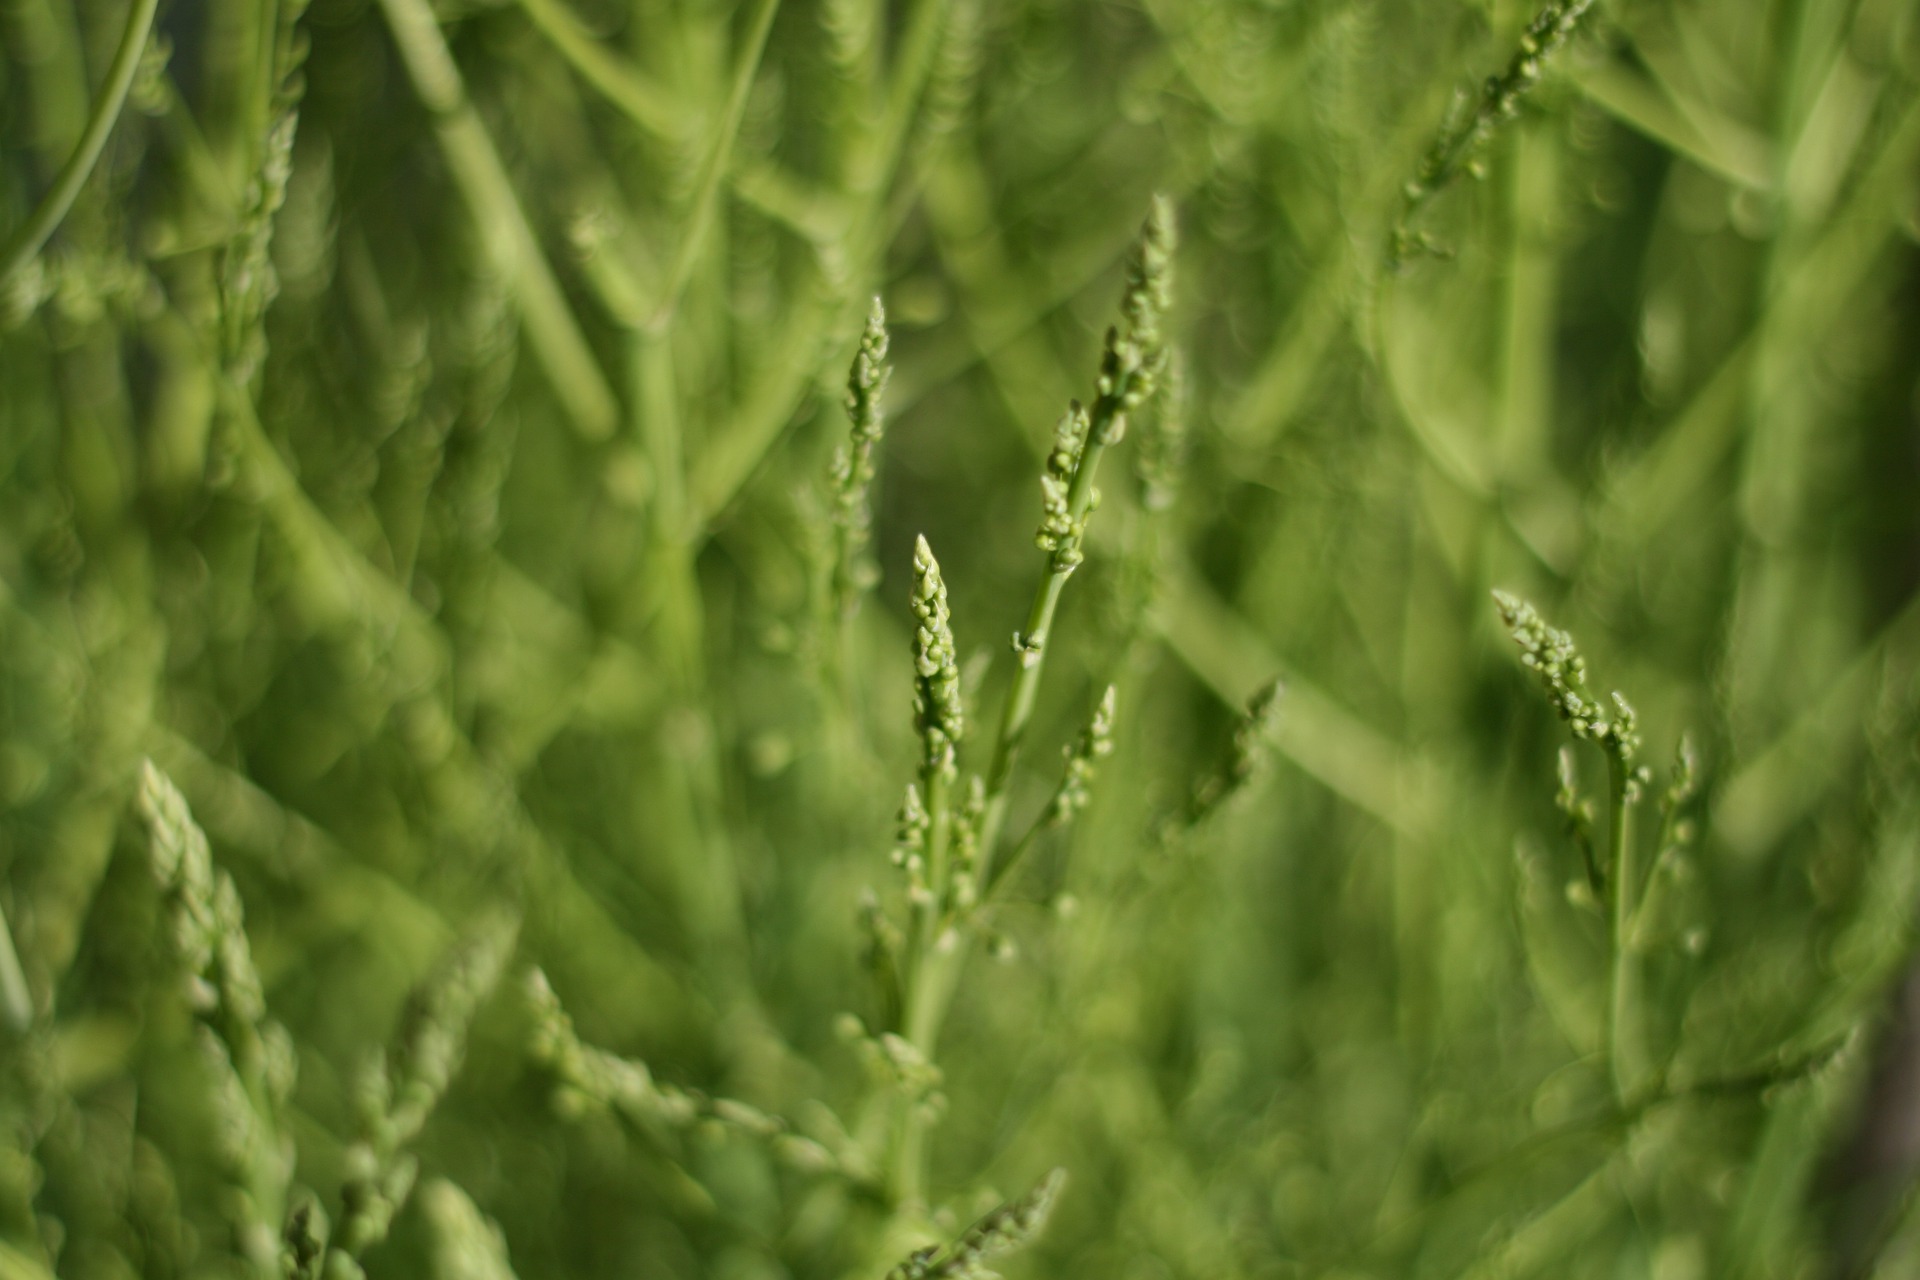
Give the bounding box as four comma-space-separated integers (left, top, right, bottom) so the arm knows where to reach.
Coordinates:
0, 0, 1920, 1280
